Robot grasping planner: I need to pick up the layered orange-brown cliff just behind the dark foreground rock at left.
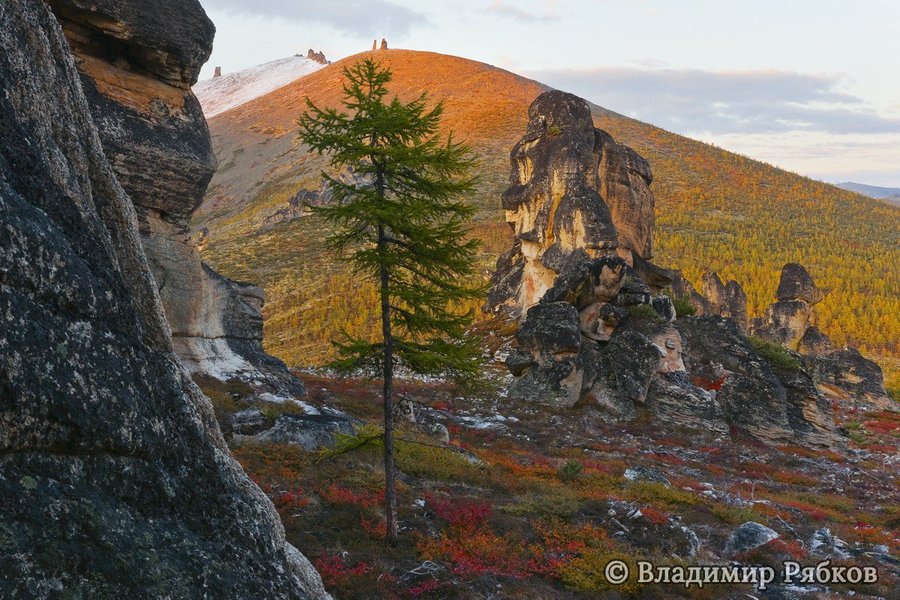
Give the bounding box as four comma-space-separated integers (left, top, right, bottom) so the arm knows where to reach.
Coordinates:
48, 0, 304, 395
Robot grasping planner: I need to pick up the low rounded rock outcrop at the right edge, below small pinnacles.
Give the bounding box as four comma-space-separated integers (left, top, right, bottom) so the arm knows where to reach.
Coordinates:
805, 348, 896, 409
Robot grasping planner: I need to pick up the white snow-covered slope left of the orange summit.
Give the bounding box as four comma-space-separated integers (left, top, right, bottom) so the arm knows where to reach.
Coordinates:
194, 55, 325, 119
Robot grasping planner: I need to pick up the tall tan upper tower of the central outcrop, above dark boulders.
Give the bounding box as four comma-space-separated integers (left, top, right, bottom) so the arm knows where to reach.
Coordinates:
488, 91, 654, 315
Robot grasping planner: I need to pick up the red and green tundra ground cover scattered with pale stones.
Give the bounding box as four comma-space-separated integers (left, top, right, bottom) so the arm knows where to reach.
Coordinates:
223, 376, 900, 598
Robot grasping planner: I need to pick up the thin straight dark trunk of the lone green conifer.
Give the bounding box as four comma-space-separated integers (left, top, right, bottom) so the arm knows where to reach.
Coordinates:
378, 225, 397, 546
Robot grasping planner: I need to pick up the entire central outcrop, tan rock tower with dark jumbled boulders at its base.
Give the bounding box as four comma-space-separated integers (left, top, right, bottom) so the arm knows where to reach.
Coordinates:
488, 92, 835, 446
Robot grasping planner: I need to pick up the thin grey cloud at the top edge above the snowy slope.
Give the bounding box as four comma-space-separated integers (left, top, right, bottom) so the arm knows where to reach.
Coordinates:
202, 0, 428, 37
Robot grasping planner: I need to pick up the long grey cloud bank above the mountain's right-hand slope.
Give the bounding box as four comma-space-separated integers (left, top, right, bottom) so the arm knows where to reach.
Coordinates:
527, 68, 900, 135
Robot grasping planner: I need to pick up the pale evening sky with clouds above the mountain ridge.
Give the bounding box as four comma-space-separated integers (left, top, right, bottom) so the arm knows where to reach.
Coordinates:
200, 0, 900, 187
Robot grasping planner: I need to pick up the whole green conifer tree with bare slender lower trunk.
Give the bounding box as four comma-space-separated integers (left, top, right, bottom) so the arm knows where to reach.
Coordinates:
299, 59, 483, 544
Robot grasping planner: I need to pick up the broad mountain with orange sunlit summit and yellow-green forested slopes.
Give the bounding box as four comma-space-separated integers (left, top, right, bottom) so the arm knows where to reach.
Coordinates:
192, 50, 900, 384
